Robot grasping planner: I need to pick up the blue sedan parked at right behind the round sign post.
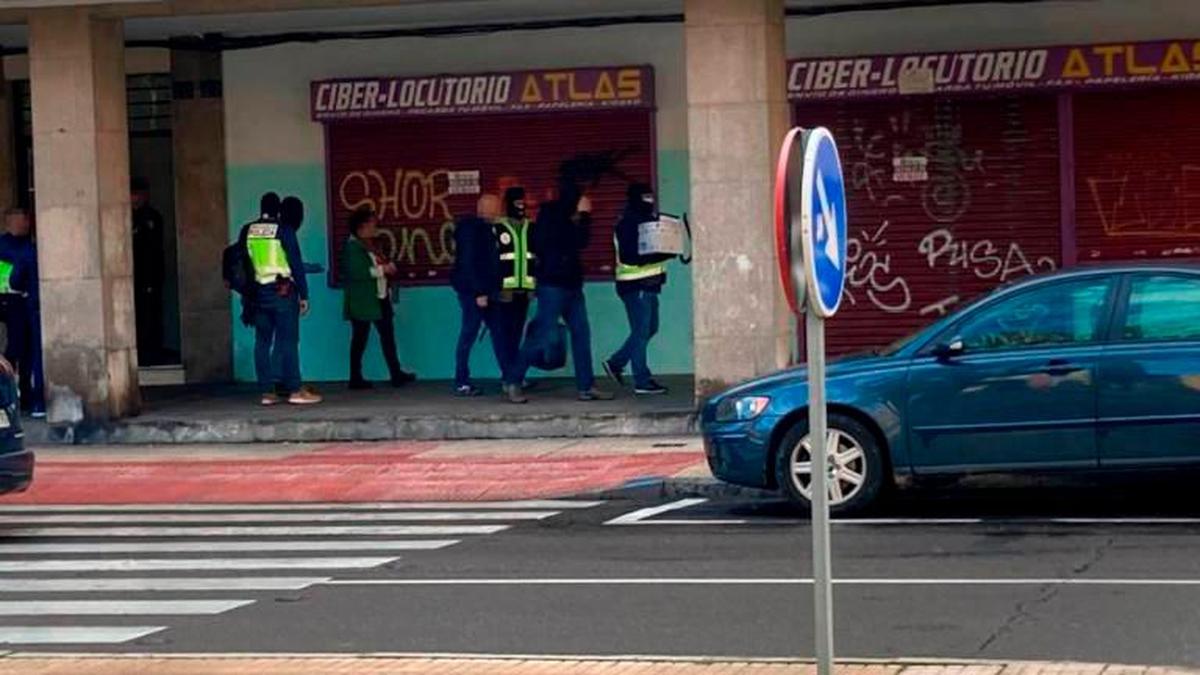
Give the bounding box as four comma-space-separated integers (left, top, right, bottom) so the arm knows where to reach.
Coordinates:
701, 264, 1200, 515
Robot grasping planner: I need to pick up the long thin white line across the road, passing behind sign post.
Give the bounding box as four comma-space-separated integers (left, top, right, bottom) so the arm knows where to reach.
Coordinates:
322, 577, 1200, 586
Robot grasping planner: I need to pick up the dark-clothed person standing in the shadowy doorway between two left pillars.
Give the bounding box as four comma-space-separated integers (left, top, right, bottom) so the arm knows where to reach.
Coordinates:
130, 178, 167, 365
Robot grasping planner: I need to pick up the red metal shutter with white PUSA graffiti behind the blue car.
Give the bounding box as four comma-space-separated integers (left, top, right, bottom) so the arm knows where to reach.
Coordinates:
796, 96, 1061, 353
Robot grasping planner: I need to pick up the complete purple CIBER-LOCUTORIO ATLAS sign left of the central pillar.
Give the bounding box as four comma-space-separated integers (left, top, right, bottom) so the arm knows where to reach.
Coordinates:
311, 66, 654, 121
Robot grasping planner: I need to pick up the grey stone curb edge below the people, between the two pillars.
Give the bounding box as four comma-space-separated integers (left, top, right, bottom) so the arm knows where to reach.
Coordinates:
25, 410, 696, 446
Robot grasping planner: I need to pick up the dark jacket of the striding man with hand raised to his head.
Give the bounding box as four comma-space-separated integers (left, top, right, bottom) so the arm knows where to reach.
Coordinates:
529, 198, 592, 289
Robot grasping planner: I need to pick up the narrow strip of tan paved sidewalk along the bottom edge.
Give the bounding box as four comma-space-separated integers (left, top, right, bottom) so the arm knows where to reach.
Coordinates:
0, 653, 1185, 675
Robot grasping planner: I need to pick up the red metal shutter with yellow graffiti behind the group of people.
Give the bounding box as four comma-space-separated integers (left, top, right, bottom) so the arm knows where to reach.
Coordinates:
325, 110, 654, 285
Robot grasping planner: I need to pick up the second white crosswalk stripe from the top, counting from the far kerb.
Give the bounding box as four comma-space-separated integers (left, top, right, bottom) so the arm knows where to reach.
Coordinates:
0, 510, 559, 526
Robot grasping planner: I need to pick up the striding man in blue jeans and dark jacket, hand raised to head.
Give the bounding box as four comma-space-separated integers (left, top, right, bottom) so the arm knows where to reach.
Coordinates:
504, 181, 612, 404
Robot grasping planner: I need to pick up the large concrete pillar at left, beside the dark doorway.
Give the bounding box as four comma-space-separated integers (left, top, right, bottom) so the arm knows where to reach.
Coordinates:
29, 7, 140, 422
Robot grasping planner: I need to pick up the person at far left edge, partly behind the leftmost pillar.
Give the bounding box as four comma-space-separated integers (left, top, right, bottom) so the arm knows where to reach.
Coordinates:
0, 209, 46, 418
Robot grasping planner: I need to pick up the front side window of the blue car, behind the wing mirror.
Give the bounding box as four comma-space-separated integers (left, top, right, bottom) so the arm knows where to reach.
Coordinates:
955, 277, 1112, 352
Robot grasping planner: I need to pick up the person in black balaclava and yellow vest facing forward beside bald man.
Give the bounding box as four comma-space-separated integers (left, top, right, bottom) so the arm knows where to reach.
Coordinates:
494, 186, 538, 374
